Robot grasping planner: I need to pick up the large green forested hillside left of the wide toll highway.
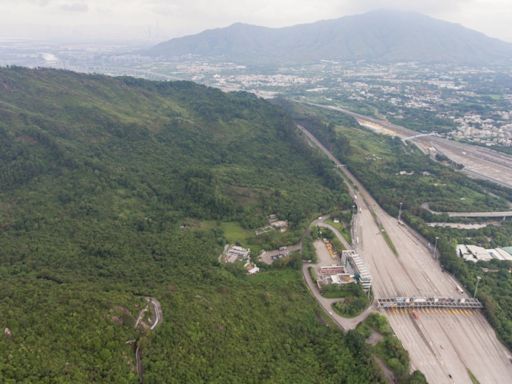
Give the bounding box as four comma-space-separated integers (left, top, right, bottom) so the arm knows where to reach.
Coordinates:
0, 68, 381, 383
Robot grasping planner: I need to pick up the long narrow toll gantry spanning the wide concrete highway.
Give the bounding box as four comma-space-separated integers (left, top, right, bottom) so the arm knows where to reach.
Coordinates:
377, 297, 483, 309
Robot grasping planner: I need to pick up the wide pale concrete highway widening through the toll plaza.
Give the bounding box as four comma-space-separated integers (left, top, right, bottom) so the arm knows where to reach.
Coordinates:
298, 126, 512, 384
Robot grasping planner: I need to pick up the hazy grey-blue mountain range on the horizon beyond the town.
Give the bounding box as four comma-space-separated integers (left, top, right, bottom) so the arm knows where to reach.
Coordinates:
144, 10, 512, 64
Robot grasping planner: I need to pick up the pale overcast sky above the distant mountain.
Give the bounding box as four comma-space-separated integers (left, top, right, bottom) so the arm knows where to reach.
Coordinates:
0, 0, 512, 42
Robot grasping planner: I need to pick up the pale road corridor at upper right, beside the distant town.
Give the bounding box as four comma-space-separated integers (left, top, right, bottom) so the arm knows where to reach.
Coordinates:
308, 103, 512, 188
